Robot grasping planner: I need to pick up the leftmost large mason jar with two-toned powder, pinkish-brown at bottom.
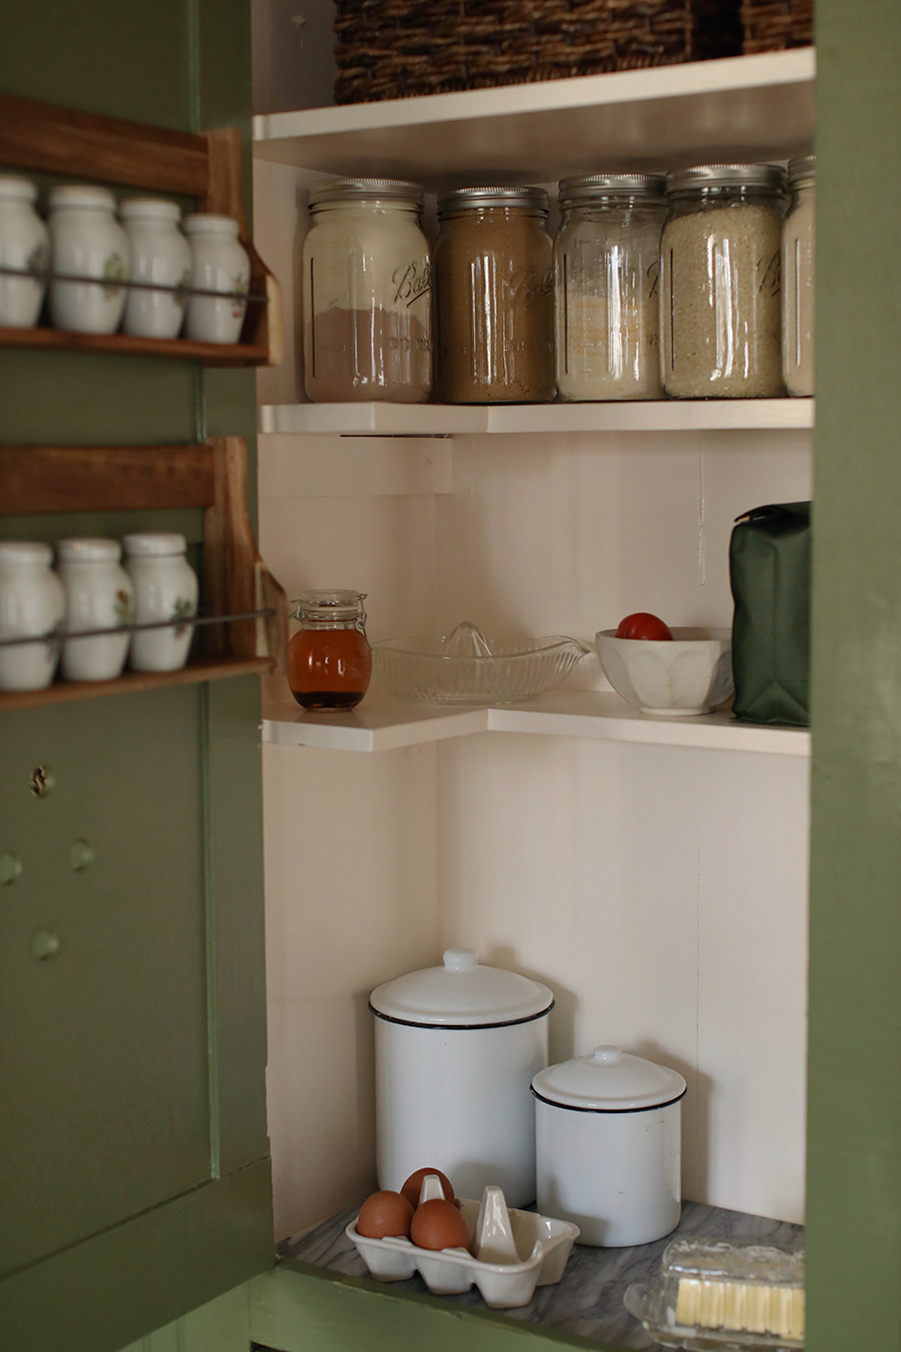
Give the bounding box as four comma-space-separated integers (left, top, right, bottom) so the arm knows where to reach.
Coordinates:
302, 178, 432, 404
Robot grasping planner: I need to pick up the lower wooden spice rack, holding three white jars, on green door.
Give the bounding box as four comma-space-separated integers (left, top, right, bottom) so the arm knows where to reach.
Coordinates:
0, 437, 288, 711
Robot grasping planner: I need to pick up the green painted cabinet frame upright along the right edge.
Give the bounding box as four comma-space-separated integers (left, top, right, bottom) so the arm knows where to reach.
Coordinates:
808, 0, 901, 1352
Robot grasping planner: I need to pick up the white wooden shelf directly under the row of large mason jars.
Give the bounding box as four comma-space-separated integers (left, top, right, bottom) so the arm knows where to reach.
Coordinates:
260, 399, 814, 437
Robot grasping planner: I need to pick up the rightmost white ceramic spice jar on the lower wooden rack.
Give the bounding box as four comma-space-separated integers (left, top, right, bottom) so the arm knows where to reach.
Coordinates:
122, 534, 198, 672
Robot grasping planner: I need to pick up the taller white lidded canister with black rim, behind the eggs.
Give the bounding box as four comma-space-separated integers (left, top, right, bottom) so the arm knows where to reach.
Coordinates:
369, 948, 553, 1207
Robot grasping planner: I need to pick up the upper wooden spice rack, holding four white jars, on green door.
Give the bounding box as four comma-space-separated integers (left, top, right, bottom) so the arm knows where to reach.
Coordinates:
0, 95, 284, 366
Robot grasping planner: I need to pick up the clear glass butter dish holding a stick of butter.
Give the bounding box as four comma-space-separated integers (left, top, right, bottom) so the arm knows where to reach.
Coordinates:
624, 1238, 805, 1352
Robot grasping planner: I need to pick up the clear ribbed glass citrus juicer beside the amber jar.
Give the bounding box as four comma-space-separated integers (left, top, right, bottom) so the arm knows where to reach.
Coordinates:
372, 621, 591, 706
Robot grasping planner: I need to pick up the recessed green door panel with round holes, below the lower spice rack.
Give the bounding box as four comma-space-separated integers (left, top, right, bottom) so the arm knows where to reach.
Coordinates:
0, 685, 210, 1271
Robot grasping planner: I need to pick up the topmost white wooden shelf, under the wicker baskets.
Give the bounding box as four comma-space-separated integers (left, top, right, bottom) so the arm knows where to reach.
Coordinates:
253, 47, 816, 189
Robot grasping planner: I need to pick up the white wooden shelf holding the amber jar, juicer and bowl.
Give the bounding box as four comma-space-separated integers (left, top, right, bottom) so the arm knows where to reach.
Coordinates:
262, 690, 810, 756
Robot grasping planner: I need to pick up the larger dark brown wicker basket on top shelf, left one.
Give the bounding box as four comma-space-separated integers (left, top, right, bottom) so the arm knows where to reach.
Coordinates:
336, 0, 741, 103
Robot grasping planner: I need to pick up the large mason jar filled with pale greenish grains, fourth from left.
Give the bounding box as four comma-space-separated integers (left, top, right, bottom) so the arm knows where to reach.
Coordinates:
660, 165, 785, 399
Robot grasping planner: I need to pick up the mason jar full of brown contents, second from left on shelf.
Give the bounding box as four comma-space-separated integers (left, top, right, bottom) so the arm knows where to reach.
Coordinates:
433, 188, 555, 404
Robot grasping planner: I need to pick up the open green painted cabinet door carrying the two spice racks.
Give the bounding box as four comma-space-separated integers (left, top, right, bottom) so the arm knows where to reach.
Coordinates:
0, 0, 272, 1352
